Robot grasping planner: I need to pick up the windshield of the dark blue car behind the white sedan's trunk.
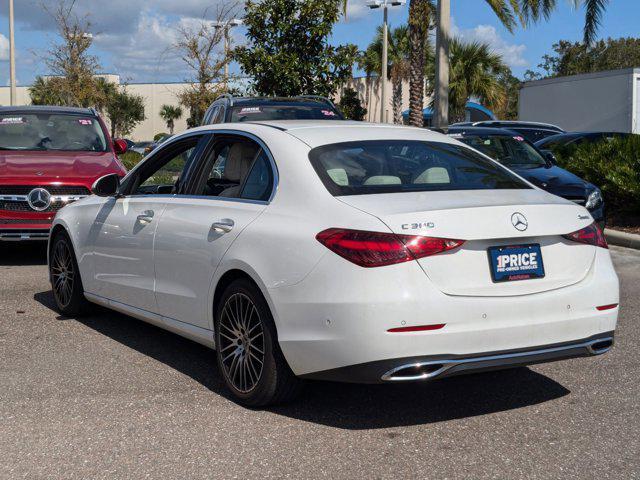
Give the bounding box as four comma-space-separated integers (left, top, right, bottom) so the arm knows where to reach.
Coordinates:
459, 135, 547, 168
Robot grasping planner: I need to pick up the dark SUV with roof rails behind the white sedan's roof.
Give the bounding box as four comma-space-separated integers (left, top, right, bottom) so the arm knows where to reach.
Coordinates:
202, 94, 344, 125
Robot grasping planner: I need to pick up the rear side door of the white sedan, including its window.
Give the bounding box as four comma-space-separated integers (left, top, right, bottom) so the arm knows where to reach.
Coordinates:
154, 134, 275, 330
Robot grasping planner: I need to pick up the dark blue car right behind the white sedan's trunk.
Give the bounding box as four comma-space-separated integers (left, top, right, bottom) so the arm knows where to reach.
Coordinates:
447, 126, 606, 227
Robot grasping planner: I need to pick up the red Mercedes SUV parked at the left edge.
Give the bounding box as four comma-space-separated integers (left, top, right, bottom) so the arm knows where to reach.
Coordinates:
0, 106, 127, 240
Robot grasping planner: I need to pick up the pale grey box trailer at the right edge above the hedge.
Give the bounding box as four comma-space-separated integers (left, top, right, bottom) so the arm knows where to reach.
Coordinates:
518, 68, 640, 134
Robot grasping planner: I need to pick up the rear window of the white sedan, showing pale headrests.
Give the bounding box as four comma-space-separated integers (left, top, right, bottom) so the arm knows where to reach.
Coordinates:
309, 140, 530, 196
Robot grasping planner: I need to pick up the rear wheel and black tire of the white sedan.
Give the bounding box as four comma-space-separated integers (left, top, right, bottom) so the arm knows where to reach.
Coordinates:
215, 279, 302, 407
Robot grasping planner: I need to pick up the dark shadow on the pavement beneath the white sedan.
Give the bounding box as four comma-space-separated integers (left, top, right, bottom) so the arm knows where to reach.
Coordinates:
34, 291, 570, 430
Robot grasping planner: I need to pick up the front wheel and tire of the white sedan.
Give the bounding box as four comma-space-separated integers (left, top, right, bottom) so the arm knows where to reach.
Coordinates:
49, 232, 90, 316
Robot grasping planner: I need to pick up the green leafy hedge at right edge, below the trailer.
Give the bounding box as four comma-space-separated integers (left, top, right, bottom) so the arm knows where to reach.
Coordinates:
554, 135, 640, 214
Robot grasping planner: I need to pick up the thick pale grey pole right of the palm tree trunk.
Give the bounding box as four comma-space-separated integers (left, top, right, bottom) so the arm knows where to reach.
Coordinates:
433, 0, 451, 128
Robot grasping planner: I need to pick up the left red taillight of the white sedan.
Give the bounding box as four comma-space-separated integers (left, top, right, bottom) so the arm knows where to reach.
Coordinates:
316, 228, 464, 267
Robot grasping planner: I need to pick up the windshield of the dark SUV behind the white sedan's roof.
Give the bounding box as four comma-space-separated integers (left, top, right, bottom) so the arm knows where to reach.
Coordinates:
231, 104, 342, 122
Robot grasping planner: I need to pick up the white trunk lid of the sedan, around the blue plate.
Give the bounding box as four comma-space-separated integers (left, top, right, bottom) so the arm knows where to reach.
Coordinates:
339, 189, 596, 296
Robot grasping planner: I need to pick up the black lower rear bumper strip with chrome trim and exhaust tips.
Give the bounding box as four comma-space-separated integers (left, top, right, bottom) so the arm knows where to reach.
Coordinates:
302, 332, 614, 383
